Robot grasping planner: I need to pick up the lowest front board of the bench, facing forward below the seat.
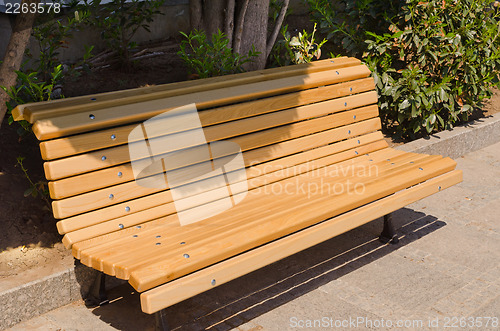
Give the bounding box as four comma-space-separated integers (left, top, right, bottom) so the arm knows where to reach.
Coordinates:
141, 170, 462, 314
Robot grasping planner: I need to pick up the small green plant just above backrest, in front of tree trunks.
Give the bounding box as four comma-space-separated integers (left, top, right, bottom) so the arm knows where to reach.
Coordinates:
177, 30, 260, 78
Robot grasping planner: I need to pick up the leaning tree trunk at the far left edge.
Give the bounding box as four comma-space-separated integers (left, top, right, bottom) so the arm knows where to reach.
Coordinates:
0, 0, 39, 125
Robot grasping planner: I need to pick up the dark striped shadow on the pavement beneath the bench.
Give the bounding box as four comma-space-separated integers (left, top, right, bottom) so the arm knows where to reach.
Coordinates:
89, 208, 446, 330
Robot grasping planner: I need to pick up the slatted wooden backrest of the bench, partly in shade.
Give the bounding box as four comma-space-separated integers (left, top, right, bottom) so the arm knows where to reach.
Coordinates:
14, 58, 387, 247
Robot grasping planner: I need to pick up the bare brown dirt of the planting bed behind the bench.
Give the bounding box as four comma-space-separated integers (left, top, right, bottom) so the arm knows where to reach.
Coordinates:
0, 31, 500, 281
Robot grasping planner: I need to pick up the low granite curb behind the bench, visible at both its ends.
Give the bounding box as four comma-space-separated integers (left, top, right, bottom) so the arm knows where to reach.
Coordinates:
0, 113, 500, 329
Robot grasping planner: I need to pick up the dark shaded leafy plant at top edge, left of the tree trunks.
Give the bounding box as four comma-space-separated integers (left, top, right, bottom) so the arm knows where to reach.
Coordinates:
79, 0, 165, 66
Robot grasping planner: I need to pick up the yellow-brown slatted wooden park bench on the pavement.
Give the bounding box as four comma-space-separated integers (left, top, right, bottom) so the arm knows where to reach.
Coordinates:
14, 57, 462, 330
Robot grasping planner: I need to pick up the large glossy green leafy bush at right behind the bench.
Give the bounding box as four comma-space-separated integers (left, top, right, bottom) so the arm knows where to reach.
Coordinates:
365, 0, 500, 138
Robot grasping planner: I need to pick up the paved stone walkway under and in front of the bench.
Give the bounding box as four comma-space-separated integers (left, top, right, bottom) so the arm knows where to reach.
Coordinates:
10, 143, 500, 331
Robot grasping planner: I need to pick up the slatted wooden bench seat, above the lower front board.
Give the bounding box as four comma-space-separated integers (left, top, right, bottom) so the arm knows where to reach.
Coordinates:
73, 144, 458, 292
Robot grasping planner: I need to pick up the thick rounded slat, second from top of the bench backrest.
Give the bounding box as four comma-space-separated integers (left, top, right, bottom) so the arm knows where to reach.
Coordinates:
33, 65, 370, 140
